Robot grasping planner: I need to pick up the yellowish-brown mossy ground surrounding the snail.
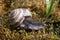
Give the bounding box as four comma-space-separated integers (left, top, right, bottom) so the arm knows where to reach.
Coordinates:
0, 0, 60, 40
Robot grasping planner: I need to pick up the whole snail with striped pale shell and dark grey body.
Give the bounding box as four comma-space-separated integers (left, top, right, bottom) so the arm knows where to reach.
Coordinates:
9, 8, 45, 30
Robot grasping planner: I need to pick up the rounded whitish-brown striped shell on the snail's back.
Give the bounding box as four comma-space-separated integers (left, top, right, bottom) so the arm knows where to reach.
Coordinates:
9, 8, 32, 27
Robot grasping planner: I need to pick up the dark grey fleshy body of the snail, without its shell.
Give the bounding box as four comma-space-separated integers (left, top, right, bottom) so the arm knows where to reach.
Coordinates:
20, 18, 45, 30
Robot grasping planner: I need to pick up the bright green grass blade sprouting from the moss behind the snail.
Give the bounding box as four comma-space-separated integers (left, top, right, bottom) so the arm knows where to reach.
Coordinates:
46, 0, 55, 18
